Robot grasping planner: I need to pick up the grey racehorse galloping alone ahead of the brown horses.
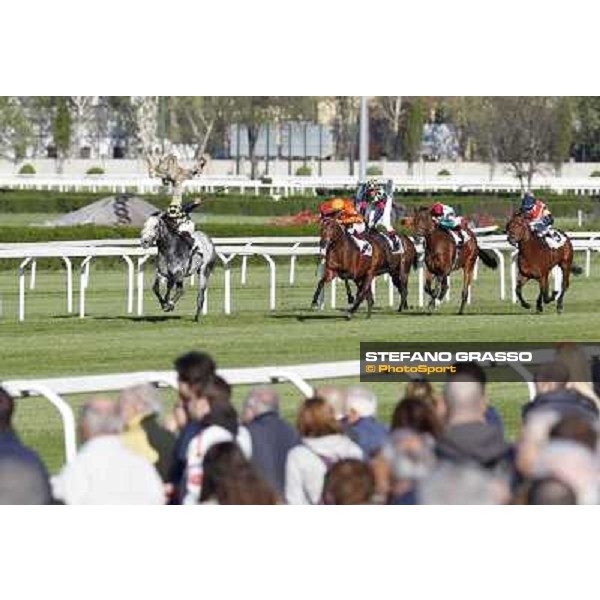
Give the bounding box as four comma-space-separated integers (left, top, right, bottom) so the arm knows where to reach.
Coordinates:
140, 213, 217, 321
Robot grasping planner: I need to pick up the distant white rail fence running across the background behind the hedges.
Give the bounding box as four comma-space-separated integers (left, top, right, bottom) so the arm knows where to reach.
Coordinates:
0, 175, 600, 196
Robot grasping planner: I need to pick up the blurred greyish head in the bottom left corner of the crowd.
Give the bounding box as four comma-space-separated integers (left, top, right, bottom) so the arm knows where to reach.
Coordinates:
0, 455, 52, 504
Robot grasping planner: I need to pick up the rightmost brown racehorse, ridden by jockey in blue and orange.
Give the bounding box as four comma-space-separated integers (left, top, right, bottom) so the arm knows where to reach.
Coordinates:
506, 212, 581, 312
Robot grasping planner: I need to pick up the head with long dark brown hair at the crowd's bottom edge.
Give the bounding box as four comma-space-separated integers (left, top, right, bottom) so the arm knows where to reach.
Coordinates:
200, 442, 278, 504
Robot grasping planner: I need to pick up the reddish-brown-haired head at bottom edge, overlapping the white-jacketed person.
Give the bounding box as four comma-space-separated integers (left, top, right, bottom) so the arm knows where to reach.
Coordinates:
323, 458, 375, 505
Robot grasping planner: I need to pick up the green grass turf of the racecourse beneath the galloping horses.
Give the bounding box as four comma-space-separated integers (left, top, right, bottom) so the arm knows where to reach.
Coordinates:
0, 258, 600, 471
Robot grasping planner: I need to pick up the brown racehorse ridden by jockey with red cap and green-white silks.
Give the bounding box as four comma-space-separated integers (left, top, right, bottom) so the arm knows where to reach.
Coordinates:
413, 206, 498, 315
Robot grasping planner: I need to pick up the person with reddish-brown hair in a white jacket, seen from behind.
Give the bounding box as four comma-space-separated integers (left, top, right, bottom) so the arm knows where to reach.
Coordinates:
285, 398, 364, 504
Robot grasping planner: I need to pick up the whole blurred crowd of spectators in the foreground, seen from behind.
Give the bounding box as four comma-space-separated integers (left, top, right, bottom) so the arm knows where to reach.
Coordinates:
0, 343, 600, 504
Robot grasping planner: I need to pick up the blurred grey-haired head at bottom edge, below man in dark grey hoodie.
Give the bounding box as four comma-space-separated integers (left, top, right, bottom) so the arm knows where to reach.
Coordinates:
417, 463, 510, 505
